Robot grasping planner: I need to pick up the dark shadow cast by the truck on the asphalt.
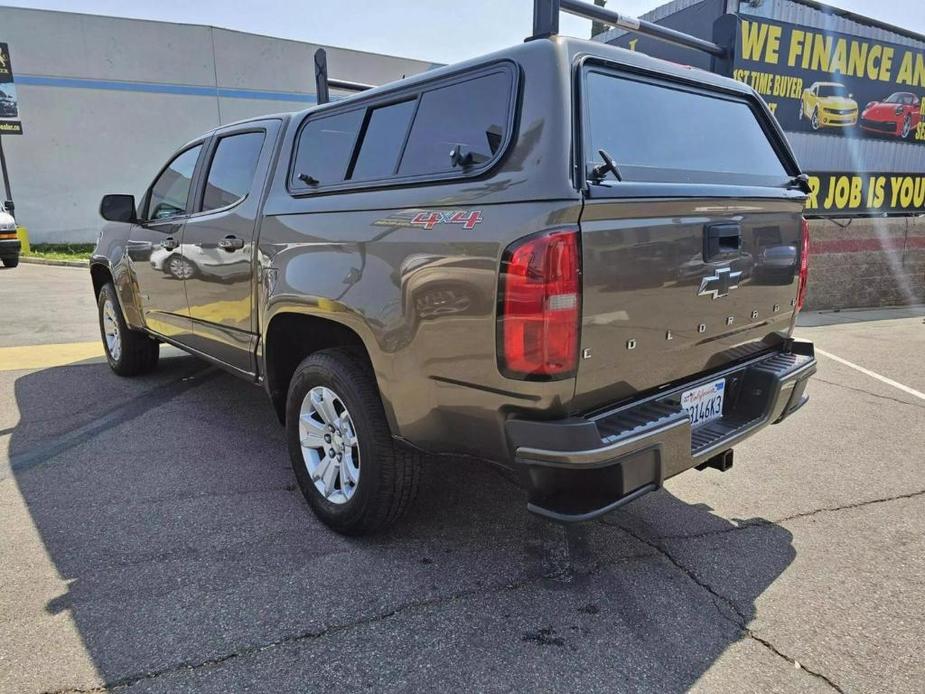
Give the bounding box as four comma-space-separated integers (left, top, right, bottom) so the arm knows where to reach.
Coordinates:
9, 357, 794, 691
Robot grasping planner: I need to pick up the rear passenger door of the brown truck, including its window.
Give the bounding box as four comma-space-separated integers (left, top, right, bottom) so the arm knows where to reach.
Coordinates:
183, 120, 280, 374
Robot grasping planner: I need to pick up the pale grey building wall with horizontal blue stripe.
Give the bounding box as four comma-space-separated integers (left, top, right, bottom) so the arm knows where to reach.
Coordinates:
0, 7, 432, 243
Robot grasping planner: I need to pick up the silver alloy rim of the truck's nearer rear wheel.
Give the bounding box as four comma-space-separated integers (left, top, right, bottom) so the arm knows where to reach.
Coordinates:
299, 386, 360, 504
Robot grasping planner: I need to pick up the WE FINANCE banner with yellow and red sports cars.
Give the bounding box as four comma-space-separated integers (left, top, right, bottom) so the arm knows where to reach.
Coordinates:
733, 19, 925, 145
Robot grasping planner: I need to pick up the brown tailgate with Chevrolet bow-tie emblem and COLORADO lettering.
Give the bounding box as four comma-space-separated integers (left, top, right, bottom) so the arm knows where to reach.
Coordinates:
574, 196, 802, 410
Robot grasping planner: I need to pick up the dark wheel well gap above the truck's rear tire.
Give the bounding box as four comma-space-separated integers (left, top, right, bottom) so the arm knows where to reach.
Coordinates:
264, 313, 372, 423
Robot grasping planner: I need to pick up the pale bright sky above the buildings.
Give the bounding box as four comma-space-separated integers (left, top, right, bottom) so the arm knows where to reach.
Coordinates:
0, 0, 925, 63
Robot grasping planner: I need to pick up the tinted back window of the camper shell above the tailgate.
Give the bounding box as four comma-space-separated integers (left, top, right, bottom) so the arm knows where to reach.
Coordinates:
582, 67, 790, 187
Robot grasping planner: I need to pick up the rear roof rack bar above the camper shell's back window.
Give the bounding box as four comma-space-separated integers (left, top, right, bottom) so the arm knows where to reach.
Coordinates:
527, 0, 728, 58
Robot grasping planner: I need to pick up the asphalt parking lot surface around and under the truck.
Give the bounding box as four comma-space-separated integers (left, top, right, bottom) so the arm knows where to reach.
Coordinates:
0, 265, 925, 692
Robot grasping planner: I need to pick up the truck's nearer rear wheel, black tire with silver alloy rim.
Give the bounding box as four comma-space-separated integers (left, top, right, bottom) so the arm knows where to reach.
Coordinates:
286, 348, 421, 535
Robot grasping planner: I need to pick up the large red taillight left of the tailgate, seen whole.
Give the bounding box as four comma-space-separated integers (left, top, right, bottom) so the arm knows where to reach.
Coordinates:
498, 230, 581, 379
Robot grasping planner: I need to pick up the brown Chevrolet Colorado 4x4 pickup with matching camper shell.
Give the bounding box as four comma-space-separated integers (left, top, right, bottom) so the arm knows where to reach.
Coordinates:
90, 36, 816, 534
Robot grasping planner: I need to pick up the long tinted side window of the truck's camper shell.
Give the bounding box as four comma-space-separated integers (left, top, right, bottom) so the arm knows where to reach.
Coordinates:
289, 61, 517, 195
